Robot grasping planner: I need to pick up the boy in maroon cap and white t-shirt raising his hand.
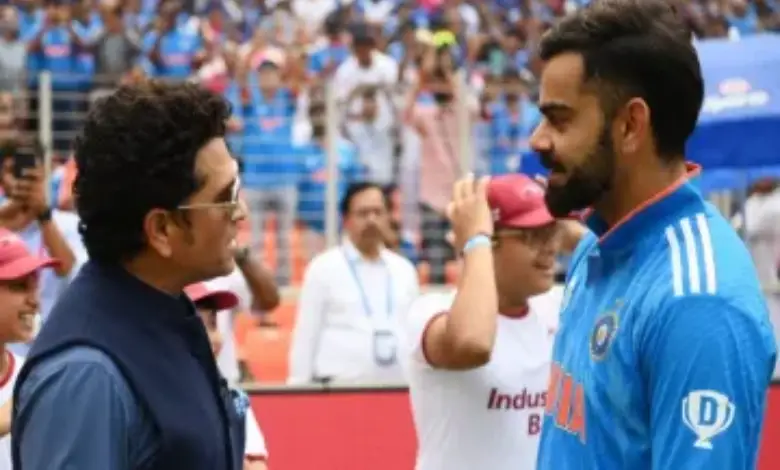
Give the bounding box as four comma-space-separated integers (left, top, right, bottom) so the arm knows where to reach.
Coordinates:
406, 174, 584, 470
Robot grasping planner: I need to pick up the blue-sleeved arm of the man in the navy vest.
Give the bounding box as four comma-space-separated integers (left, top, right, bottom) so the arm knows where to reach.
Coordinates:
13, 348, 141, 470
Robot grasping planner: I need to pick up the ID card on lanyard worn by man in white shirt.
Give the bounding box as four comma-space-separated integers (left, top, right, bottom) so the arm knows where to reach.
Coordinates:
343, 251, 398, 367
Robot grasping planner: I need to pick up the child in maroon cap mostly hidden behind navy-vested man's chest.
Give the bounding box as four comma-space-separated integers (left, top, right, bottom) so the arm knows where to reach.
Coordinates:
184, 282, 268, 470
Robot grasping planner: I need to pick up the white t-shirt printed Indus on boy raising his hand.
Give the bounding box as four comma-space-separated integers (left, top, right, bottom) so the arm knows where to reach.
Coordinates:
406, 287, 562, 470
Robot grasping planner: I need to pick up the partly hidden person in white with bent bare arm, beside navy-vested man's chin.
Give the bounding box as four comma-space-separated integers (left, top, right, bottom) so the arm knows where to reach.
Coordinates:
206, 242, 280, 385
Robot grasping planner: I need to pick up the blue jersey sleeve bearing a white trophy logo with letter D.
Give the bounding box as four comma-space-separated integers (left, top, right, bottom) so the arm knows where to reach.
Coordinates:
641, 296, 776, 470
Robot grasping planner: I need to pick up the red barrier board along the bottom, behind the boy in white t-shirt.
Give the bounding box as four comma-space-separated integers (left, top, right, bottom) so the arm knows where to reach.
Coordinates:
247, 383, 780, 470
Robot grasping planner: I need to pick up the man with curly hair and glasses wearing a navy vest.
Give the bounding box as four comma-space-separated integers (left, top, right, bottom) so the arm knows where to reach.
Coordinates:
12, 82, 246, 470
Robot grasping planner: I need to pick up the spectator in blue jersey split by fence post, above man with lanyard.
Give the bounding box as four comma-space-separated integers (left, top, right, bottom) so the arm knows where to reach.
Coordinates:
297, 104, 365, 257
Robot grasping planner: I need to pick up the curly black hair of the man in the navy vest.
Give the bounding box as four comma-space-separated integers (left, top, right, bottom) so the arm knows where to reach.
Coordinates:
73, 80, 230, 263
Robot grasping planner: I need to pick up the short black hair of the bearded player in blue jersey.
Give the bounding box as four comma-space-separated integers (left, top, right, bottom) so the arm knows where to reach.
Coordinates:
539, 0, 704, 157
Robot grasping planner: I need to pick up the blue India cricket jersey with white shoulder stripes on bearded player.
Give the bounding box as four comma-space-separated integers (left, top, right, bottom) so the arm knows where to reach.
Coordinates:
538, 166, 776, 470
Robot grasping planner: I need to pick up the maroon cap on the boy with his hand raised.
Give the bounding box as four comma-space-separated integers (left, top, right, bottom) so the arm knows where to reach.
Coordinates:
487, 173, 555, 228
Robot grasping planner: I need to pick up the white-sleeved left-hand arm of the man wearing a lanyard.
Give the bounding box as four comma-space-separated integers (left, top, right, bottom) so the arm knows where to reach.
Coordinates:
288, 257, 328, 384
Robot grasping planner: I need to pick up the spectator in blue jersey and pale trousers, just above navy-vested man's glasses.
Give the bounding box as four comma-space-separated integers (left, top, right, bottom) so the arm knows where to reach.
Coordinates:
227, 59, 303, 285
